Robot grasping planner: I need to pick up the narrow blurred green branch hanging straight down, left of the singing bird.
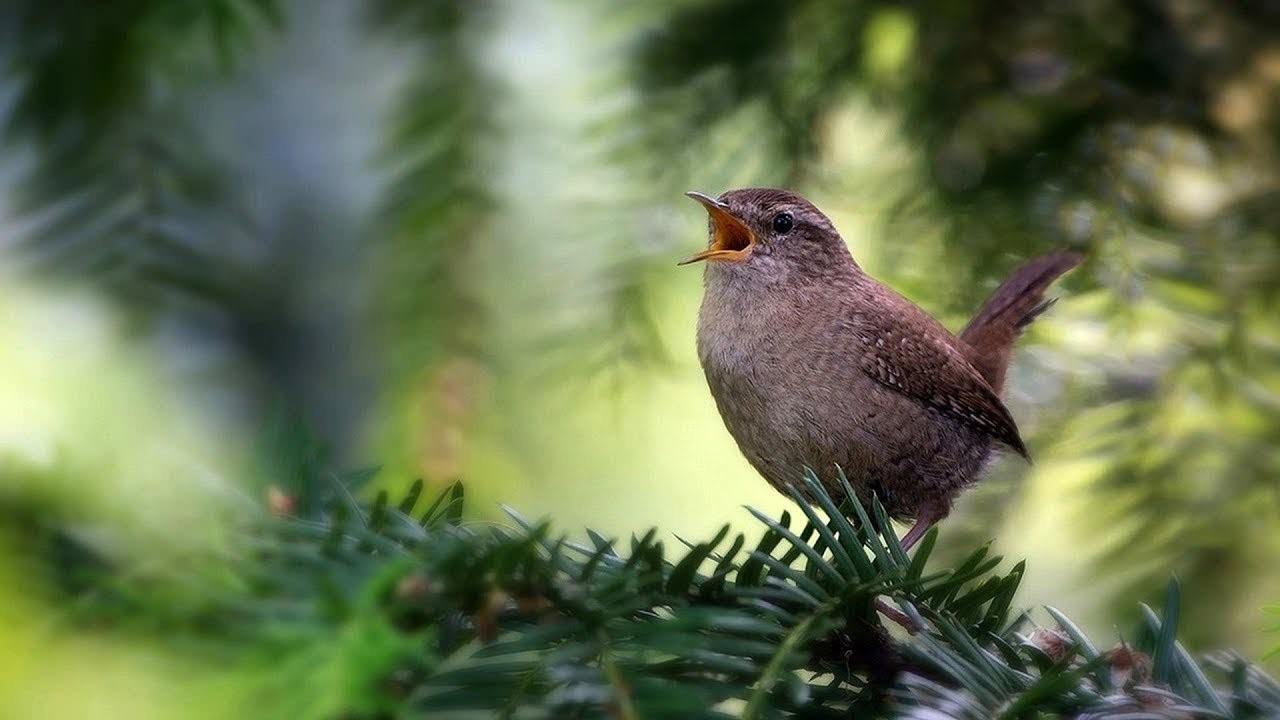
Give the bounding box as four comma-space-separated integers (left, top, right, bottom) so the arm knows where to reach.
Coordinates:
366, 0, 498, 375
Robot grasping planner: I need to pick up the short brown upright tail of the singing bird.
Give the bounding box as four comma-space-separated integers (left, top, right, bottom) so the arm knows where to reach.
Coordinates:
960, 252, 1084, 393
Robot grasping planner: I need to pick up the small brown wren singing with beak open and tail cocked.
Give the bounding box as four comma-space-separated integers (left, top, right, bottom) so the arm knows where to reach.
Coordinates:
682, 188, 1080, 547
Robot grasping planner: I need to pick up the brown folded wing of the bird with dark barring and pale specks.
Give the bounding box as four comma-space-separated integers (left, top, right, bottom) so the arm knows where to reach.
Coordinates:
854, 288, 1029, 459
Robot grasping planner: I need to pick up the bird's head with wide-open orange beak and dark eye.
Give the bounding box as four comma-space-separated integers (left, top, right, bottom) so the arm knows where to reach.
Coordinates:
681, 188, 855, 282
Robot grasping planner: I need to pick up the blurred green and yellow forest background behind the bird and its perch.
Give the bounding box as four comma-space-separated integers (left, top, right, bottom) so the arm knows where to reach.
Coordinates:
0, 0, 1280, 717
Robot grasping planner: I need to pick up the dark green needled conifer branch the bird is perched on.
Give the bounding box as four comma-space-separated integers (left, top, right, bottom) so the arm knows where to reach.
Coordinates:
220, 474, 1280, 720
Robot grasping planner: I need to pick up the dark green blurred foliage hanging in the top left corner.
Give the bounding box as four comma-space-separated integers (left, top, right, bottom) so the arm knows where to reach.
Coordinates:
0, 0, 279, 294
